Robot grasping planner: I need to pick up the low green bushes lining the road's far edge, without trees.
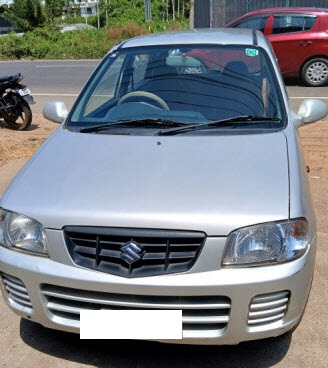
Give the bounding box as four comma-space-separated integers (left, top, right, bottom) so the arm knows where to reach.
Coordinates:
0, 17, 185, 60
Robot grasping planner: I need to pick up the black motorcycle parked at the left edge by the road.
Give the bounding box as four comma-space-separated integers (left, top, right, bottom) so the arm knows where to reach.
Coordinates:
0, 73, 35, 130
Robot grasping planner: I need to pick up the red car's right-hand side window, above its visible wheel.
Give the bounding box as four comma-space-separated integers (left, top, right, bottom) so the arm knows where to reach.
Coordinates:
272, 15, 316, 34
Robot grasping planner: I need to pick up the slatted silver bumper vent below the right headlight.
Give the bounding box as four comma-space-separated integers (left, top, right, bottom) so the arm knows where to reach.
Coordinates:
248, 291, 290, 326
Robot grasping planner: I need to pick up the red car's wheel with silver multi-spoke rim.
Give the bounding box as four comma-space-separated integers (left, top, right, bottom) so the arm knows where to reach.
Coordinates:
302, 58, 328, 87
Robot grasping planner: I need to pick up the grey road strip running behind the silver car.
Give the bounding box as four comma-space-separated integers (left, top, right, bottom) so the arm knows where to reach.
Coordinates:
0, 60, 328, 112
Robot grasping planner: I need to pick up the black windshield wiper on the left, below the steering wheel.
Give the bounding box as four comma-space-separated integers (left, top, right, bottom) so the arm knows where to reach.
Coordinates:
79, 118, 189, 133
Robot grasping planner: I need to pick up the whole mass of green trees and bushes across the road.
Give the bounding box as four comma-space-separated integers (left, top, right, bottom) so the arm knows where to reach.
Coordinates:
0, 0, 189, 60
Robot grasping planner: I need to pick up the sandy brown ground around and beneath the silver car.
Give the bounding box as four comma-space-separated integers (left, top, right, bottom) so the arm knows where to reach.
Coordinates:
0, 115, 328, 368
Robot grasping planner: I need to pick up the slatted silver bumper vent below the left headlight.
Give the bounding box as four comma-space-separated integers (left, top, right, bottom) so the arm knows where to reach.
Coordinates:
2, 273, 33, 313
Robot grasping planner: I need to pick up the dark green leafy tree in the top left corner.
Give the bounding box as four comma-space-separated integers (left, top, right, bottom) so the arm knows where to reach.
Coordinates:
3, 0, 45, 32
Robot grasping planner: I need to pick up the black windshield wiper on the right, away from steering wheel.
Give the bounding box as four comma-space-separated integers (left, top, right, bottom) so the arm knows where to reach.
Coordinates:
155, 115, 281, 135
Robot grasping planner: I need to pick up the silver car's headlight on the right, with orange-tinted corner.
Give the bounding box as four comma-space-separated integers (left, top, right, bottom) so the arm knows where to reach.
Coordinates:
222, 219, 309, 266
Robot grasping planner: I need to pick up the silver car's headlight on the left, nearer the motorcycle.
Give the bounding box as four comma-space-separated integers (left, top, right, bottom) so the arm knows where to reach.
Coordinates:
0, 208, 48, 256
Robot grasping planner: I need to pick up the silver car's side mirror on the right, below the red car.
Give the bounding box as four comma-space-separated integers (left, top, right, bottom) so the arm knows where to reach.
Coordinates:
297, 98, 328, 125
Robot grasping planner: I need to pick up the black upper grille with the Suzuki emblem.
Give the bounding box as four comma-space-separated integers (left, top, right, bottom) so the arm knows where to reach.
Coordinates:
64, 227, 205, 277
